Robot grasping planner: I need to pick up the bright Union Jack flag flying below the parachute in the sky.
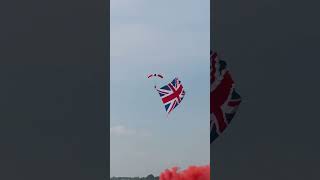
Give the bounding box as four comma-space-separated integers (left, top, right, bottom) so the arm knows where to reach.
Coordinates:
157, 78, 186, 114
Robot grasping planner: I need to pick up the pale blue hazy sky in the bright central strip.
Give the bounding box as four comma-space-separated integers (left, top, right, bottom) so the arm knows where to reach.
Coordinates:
110, 0, 210, 176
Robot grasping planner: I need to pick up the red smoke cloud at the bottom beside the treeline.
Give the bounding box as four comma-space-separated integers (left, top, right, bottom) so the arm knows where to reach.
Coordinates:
160, 165, 210, 180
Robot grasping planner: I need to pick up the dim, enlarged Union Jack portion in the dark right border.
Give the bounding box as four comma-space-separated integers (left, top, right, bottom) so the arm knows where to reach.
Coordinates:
210, 51, 241, 143
